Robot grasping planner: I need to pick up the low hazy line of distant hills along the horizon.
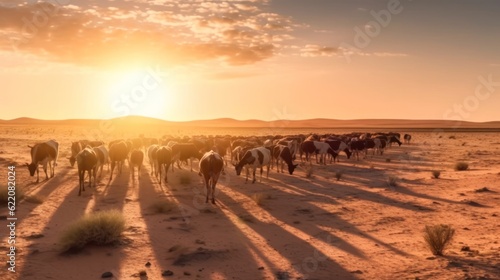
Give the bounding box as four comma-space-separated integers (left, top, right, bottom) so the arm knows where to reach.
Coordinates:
0, 116, 500, 129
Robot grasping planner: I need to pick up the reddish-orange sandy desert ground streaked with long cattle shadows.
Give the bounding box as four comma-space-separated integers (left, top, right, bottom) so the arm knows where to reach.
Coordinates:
0, 126, 500, 279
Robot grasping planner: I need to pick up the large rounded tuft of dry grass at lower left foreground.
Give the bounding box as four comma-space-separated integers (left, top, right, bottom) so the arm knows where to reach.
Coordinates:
60, 210, 125, 252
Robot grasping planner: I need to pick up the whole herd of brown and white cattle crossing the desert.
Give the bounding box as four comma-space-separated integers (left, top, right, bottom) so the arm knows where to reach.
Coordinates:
26, 132, 411, 203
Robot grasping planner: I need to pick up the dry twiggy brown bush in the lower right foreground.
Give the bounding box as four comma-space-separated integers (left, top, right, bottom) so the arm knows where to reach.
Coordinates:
424, 225, 455, 256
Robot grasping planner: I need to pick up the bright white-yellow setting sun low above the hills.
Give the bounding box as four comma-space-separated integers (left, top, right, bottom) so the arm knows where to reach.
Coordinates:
107, 68, 176, 119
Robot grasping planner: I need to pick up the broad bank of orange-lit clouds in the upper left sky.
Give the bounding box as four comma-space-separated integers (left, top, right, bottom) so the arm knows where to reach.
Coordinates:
0, 0, 294, 67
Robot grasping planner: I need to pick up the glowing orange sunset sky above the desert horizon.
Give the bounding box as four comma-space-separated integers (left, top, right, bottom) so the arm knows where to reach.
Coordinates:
0, 0, 500, 122
